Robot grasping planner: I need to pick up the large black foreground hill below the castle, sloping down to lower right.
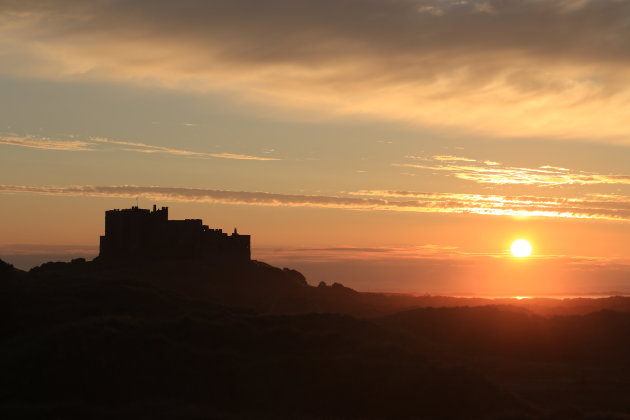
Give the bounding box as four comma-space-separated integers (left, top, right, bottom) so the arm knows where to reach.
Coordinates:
0, 261, 532, 419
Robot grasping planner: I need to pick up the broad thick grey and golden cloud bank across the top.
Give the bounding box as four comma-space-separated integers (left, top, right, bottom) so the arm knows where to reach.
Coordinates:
0, 0, 630, 144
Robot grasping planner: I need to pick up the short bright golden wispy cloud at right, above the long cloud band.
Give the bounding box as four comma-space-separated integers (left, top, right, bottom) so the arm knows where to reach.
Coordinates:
394, 156, 630, 187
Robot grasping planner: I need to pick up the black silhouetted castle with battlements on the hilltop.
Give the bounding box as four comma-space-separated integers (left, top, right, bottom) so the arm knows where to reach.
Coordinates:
99, 204, 251, 261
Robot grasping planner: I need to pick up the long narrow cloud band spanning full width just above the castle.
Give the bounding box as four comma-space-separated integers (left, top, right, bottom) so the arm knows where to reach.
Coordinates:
0, 185, 630, 222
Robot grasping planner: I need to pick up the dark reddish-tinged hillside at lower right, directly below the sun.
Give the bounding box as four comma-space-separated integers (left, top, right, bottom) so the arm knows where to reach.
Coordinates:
377, 306, 630, 419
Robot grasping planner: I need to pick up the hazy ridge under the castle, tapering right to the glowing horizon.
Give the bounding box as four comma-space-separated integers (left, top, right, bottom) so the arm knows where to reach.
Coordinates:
16, 258, 630, 318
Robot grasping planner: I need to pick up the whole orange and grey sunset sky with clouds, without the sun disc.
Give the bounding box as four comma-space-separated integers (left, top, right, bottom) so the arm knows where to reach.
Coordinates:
0, 0, 630, 295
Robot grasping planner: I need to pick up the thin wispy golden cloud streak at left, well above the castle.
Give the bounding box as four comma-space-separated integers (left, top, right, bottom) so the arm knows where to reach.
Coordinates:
0, 136, 280, 161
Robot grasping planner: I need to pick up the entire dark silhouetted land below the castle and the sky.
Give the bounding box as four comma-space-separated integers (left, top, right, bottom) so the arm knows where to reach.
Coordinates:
0, 259, 630, 419
